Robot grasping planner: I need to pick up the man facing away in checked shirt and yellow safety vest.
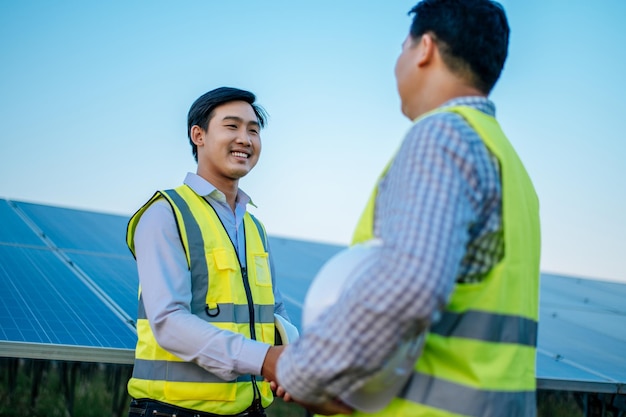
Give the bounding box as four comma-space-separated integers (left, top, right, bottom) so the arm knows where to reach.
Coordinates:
277, 0, 540, 417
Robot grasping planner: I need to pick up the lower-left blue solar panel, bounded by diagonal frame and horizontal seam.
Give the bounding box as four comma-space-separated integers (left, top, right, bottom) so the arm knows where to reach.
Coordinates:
0, 246, 136, 349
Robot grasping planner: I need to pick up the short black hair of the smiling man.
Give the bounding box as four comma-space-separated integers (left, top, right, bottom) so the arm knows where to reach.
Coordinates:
187, 87, 267, 162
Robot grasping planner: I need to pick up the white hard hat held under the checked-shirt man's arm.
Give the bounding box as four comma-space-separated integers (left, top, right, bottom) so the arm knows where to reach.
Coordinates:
302, 239, 424, 413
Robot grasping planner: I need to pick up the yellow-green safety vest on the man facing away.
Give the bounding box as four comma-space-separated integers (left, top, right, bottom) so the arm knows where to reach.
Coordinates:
353, 106, 541, 417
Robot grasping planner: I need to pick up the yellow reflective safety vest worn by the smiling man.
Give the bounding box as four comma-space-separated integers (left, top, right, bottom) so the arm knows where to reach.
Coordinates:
126, 185, 274, 414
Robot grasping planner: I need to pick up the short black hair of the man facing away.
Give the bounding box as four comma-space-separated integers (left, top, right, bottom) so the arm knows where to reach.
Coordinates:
409, 0, 510, 94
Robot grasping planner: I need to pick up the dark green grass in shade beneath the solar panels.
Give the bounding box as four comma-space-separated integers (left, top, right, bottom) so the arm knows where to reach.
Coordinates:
0, 358, 588, 417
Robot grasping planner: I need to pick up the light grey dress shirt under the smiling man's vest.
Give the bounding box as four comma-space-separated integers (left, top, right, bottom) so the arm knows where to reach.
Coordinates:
135, 173, 288, 380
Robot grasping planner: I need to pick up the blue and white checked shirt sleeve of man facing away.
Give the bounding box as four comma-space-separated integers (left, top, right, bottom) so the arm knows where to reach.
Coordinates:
278, 109, 496, 403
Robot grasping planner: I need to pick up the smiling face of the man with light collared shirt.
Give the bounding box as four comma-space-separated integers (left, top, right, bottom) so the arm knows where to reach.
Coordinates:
191, 101, 261, 188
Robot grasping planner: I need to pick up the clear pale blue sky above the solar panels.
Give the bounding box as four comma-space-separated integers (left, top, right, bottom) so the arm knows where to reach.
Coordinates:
0, 0, 626, 281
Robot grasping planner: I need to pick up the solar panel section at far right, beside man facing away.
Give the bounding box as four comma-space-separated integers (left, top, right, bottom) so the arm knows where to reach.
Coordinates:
537, 274, 626, 383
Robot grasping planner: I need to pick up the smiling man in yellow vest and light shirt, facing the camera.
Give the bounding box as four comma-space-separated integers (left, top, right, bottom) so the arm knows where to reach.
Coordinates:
127, 87, 288, 417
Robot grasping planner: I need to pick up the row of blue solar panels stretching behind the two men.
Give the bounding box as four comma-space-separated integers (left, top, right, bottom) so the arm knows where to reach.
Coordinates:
0, 199, 626, 393
